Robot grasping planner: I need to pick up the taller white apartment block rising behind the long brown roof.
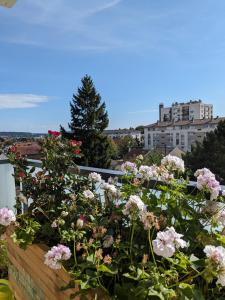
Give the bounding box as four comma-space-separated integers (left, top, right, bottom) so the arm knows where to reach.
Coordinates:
159, 100, 213, 122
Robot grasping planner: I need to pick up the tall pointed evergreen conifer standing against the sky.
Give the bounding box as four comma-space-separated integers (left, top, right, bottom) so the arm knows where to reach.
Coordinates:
61, 75, 111, 168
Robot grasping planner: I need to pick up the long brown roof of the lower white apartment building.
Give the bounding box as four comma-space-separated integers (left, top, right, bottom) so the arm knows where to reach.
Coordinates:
144, 117, 225, 128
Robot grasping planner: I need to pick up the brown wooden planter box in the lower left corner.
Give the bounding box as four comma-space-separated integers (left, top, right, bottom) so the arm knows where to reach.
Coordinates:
6, 230, 106, 300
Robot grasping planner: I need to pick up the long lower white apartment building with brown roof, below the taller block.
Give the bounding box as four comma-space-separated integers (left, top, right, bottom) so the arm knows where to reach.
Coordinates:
144, 118, 225, 152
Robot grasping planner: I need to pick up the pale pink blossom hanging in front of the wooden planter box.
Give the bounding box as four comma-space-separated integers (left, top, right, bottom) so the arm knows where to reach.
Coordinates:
44, 245, 71, 269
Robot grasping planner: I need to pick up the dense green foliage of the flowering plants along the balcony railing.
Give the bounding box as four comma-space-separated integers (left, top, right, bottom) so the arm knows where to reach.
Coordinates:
6, 136, 225, 300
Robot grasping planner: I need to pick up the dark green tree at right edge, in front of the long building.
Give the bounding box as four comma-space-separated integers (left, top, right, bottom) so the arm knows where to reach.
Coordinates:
184, 121, 225, 184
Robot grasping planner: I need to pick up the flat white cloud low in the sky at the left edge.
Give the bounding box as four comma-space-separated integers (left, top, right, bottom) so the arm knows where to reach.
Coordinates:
0, 94, 50, 109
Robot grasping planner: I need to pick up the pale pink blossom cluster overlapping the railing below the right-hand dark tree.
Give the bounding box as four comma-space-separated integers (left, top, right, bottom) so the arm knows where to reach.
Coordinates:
194, 168, 221, 200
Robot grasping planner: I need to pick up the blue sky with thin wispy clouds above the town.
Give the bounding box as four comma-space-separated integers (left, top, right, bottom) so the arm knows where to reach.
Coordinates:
0, 0, 225, 132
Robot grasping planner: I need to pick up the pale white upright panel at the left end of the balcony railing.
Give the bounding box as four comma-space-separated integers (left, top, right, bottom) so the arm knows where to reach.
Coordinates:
0, 162, 16, 211
